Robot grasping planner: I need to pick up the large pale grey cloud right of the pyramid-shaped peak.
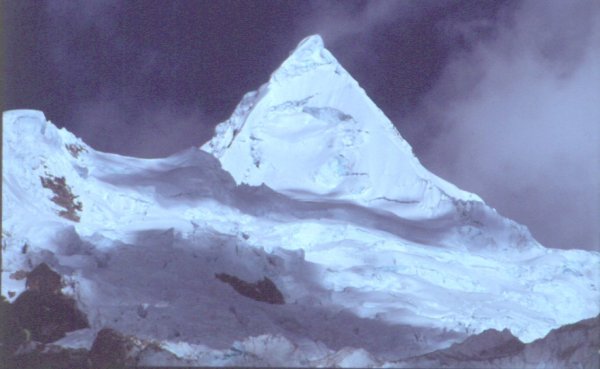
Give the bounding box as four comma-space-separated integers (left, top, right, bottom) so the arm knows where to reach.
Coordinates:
411, 0, 600, 249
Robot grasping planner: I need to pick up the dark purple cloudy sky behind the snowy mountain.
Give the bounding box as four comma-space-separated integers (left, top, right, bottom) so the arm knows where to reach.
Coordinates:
1, 0, 600, 250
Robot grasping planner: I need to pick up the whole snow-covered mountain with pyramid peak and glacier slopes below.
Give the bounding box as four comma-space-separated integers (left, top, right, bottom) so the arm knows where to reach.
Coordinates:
2, 36, 600, 366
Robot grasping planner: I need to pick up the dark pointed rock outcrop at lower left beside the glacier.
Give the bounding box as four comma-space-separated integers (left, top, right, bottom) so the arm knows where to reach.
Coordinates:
12, 263, 89, 343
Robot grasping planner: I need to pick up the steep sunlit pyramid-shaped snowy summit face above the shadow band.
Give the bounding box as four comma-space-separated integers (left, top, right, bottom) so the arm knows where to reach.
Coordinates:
202, 36, 480, 218
